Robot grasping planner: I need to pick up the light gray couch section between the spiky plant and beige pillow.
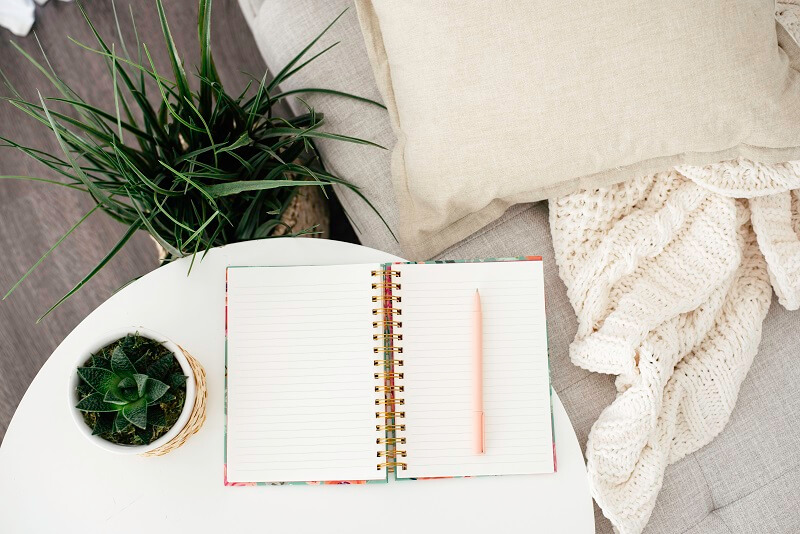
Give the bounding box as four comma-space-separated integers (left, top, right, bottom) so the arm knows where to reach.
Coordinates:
240, 0, 401, 255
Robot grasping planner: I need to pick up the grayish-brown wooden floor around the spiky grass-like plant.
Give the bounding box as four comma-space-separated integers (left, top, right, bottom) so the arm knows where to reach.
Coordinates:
0, 0, 347, 440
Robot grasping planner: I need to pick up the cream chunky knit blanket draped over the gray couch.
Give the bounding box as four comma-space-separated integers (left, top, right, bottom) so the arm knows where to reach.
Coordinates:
550, 5, 800, 534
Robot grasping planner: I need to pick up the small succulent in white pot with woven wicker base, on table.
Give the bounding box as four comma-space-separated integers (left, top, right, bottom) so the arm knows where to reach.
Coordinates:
68, 328, 205, 456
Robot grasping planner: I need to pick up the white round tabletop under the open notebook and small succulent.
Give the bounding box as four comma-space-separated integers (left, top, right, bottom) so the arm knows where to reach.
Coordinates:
0, 239, 594, 534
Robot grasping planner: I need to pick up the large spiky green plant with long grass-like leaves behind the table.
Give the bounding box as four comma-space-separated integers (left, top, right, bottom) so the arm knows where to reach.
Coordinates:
0, 0, 383, 320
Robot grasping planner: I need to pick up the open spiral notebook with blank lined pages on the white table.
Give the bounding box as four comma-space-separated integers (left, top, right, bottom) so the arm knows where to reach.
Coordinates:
225, 257, 555, 485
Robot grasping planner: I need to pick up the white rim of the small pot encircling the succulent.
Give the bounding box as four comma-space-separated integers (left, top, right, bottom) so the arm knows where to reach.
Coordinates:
67, 327, 197, 454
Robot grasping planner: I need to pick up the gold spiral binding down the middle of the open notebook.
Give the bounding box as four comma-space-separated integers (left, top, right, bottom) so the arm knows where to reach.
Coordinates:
371, 266, 408, 472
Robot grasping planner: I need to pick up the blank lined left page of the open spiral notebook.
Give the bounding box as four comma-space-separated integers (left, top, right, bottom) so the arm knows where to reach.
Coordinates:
226, 264, 386, 482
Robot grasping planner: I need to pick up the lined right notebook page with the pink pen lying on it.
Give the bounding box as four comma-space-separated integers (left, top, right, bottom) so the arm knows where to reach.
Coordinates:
393, 261, 554, 478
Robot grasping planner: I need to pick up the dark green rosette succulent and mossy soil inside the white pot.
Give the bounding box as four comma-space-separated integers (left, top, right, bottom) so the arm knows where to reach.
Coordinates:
75, 334, 187, 445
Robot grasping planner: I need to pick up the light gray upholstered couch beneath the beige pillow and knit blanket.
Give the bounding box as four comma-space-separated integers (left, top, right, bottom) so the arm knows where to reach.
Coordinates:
240, 0, 800, 534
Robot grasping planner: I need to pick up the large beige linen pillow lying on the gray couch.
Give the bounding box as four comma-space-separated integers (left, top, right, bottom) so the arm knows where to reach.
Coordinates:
356, 0, 800, 259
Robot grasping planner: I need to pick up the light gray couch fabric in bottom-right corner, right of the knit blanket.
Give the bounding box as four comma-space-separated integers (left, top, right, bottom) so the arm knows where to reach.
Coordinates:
646, 298, 800, 534
